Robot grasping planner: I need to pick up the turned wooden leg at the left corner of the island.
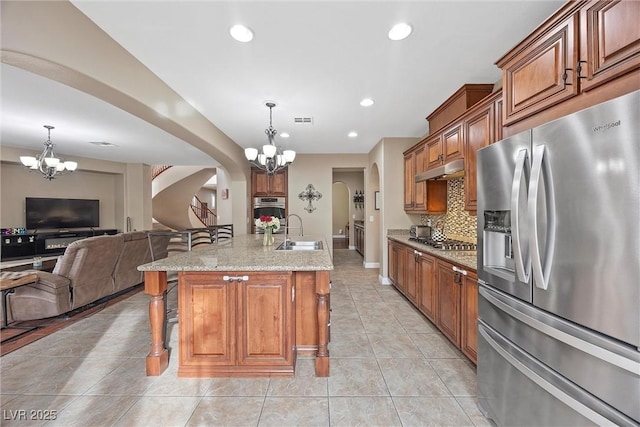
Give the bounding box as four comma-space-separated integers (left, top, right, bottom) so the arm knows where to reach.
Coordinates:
144, 271, 169, 376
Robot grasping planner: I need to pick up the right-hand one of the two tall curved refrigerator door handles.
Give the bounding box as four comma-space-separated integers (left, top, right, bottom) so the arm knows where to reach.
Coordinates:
527, 145, 556, 290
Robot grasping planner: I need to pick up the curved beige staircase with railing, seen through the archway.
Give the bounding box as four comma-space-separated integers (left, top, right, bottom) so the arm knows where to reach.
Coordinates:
151, 166, 217, 230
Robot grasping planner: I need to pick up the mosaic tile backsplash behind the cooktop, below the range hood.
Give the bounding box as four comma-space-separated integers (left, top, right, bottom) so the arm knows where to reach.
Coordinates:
420, 178, 478, 242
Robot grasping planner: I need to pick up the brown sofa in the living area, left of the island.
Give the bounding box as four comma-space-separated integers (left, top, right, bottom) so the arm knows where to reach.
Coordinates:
7, 231, 151, 321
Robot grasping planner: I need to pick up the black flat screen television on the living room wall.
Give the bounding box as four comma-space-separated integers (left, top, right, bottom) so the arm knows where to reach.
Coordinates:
25, 197, 100, 230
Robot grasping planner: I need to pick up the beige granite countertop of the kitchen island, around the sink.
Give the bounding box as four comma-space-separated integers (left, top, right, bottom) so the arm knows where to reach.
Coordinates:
138, 234, 333, 271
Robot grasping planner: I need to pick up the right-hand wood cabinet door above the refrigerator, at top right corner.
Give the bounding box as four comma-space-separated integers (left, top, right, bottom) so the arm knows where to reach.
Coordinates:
580, 0, 640, 90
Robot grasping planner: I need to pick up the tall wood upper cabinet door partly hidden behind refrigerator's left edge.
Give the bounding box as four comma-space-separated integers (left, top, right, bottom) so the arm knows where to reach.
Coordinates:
464, 104, 493, 211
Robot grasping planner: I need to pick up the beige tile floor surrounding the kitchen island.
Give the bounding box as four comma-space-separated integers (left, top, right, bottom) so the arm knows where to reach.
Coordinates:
0, 249, 489, 427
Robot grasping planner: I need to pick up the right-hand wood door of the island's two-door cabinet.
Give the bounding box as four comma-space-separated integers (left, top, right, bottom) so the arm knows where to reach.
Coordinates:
237, 273, 295, 366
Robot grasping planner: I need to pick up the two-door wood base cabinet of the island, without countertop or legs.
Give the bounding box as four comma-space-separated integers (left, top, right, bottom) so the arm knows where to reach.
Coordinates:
178, 272, 296, 377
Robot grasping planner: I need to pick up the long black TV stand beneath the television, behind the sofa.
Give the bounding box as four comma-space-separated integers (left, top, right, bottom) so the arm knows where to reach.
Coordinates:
1, 229, 118, 261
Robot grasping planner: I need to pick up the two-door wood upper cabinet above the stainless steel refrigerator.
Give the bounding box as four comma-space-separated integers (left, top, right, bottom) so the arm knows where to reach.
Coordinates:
496, 0, 640, 127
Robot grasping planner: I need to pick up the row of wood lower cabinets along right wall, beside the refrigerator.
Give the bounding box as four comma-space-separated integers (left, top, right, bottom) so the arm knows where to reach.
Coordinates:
388, 240, 478, 363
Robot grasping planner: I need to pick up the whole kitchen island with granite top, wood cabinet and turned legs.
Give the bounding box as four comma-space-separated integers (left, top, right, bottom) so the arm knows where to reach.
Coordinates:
138, 234, 333, 377
